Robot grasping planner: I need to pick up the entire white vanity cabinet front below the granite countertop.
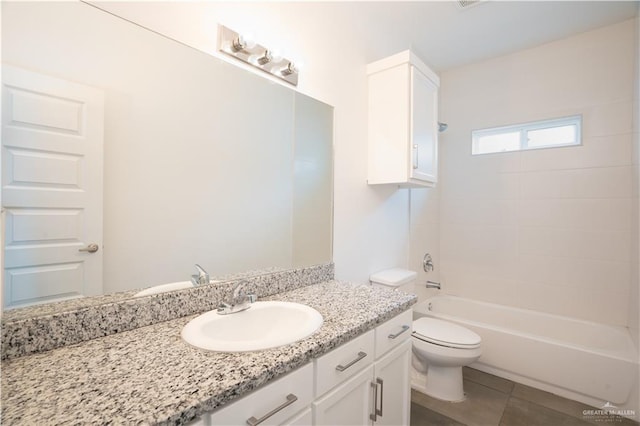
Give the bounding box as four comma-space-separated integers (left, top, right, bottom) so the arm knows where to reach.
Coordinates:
189, 310, 413, 426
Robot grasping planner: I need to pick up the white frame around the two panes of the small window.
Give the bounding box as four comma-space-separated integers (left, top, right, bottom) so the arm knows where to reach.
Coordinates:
471, 115, 582, 155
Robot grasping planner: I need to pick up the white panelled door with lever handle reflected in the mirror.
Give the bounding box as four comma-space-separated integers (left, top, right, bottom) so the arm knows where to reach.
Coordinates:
2, 66, 104, 308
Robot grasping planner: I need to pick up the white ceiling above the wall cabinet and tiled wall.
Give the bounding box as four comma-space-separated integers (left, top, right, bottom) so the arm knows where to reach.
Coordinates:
356, 1, 640, 71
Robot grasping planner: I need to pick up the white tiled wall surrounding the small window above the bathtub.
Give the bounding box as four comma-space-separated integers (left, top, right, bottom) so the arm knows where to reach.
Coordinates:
436, 20, 638, 325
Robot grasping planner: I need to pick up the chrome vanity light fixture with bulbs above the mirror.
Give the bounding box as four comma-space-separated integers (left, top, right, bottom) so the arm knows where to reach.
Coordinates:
218, 25, 299, 86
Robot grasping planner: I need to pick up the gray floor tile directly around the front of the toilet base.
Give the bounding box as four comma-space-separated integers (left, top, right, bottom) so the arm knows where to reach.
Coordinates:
411, 381, 509, 426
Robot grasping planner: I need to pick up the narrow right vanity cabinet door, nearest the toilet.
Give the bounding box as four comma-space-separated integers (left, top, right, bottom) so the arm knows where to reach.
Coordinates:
375, 340, 411, 426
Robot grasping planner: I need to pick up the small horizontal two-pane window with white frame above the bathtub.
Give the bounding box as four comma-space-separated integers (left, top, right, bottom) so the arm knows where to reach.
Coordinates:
471, 115, 582, 155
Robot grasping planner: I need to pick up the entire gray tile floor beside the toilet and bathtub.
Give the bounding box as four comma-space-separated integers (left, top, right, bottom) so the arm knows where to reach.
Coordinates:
411, 367, 638, 426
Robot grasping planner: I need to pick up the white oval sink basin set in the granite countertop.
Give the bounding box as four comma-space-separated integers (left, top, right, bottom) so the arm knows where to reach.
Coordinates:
182, 302, 322, 352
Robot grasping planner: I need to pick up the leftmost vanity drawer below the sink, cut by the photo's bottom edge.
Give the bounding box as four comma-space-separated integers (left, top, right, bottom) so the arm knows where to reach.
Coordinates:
208, 363, 313, 425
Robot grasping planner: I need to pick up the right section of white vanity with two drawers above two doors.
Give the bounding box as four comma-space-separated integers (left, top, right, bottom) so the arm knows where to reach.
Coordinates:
312, 311, 412, 426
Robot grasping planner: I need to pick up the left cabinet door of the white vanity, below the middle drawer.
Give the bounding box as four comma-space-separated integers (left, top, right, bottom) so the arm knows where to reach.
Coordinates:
313, 365, 373, 426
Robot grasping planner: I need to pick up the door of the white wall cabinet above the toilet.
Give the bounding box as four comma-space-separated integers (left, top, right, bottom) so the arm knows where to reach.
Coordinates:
411, 66, 438, 184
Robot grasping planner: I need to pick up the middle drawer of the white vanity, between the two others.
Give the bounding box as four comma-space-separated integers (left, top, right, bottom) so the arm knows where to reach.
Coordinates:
314, 330, 375, 397
